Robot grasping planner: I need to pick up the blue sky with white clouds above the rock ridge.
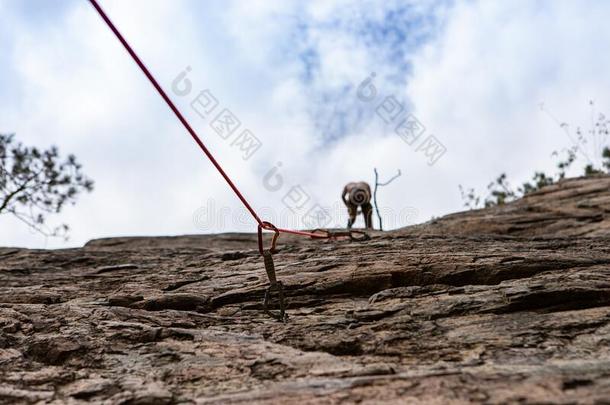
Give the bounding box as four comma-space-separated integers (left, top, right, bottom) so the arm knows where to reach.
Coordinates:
0, 0, 610, 248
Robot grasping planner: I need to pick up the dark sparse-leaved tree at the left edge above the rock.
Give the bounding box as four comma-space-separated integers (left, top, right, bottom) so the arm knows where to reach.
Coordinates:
0, 134, 93, 239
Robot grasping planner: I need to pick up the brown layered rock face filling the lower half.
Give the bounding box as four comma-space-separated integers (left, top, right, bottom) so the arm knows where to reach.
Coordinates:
0, 177, 610, 404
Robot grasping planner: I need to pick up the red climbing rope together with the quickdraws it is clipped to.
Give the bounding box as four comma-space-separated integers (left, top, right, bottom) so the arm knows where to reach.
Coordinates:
89, 0, 368, 322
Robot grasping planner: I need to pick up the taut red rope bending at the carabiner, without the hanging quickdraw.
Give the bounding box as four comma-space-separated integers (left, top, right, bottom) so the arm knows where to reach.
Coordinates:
89, 0, 329, 243
